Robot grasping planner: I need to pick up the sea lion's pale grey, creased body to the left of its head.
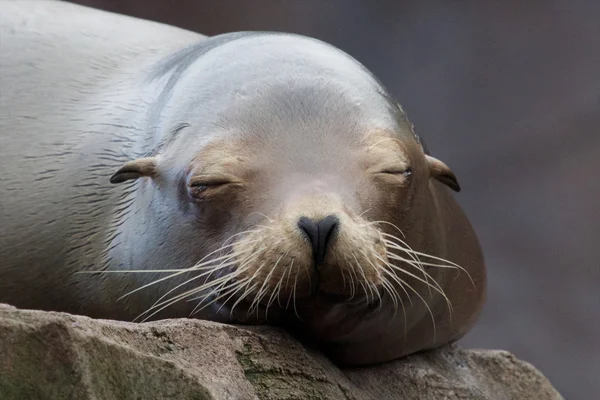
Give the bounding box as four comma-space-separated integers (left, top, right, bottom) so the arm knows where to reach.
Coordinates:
0, 1, 203, 319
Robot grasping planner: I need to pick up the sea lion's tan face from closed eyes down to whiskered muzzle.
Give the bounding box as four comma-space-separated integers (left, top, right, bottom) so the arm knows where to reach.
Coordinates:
187, 127, 415, 307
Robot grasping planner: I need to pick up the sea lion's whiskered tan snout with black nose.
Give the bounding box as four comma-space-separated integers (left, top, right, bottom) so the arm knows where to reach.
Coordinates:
227, 192, 387, 307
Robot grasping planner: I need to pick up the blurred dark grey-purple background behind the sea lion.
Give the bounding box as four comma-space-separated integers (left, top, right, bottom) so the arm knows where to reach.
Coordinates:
74, 0, 600, 399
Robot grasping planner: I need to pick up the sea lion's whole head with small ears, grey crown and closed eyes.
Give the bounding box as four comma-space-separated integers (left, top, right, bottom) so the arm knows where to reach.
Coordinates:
112, 33, 459, 336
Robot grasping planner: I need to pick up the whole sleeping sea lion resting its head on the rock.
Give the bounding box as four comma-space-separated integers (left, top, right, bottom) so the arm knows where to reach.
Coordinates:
0, 0, 485, 365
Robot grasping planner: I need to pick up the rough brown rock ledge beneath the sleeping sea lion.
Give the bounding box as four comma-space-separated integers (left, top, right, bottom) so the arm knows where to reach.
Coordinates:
0, 305, 562, 400
